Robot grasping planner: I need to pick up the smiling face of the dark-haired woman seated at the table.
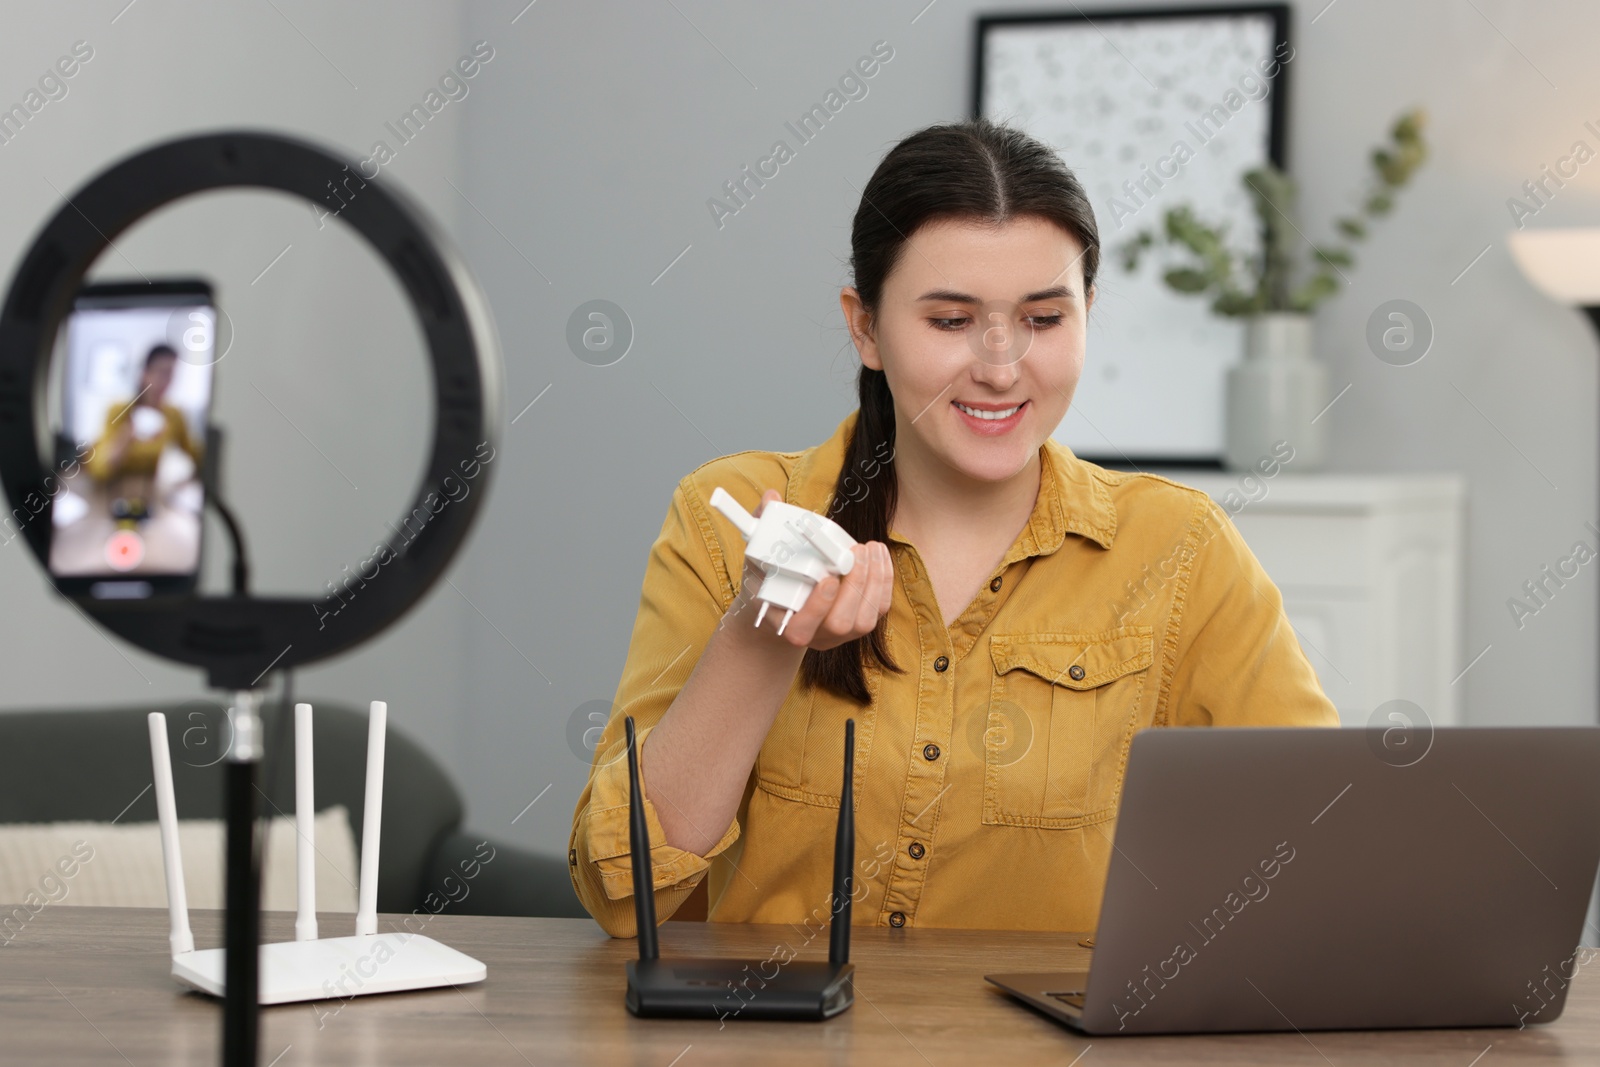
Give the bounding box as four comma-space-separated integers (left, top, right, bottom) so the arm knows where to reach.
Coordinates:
840, 216, 1094, 482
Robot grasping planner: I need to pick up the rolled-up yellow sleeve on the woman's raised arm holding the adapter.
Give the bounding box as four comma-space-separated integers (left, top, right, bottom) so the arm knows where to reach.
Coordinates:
568, 478, 742, 937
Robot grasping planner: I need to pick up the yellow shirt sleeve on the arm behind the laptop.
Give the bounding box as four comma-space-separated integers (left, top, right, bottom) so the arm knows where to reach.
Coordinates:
1166, 499, 1339, 726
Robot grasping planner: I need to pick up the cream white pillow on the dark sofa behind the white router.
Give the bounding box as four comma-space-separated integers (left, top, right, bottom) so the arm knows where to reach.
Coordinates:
0, 805, 357, 912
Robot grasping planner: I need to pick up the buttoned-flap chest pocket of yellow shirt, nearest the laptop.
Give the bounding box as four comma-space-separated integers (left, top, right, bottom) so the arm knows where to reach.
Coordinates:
982, 625, 1154, 829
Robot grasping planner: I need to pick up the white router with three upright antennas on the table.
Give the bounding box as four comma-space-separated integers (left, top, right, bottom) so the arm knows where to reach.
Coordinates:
150, 701, 488, 1005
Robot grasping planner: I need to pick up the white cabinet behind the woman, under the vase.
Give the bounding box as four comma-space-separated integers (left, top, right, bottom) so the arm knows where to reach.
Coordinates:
1154, 470, 1467, 726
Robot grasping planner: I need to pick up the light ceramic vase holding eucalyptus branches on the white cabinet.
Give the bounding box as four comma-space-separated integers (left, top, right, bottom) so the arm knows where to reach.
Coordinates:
1222, 312, 1328, 470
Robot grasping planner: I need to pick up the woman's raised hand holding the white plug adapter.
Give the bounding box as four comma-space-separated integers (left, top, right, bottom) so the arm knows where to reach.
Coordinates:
728, 490, 894, 651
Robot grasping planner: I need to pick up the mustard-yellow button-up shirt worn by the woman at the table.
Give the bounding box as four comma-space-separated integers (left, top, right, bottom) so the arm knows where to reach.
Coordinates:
568, 413, 1338, 936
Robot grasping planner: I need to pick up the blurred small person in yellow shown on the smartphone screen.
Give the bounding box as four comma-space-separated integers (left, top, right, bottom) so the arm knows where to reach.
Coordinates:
83, 344, 203, 523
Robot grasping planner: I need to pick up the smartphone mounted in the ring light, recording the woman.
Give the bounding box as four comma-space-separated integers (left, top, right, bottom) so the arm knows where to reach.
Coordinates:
46, 278, 218, 600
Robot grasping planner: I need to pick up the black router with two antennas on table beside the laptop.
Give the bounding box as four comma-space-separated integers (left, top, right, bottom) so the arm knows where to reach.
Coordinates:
627, 715, 856, 1019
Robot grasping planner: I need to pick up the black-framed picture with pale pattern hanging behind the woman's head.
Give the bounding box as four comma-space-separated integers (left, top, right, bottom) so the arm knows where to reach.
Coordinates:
973, 3, 1294, 467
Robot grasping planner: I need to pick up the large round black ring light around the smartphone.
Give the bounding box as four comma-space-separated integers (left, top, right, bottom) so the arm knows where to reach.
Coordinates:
0, 133, 501, 689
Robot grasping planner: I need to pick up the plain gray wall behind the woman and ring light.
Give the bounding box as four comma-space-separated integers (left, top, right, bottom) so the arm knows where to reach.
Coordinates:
0, 0, 1600, 853
